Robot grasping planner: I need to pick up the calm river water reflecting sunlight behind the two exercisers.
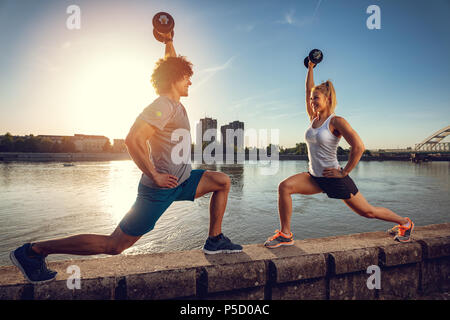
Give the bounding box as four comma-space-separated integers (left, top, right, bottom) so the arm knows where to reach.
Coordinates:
0, 161, 450, 265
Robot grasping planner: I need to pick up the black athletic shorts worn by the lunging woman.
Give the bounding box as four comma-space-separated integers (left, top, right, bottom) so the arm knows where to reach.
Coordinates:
308, 172, 358, 199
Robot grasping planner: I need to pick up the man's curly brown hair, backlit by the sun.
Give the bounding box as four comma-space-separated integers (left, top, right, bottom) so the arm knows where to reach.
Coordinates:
151, 56, 194, 95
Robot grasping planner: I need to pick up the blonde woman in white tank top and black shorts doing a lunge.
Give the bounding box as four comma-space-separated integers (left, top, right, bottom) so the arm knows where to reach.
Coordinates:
264, 62, 414, 248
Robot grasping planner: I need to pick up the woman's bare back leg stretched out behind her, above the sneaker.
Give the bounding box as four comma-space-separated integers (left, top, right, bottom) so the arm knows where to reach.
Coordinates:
343, 192, 408, 225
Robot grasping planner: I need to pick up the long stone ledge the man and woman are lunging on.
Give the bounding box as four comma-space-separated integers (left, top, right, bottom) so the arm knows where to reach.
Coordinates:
0, 223, 450, 300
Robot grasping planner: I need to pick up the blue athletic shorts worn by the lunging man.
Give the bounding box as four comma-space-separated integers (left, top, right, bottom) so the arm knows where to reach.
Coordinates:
119, 170, 206, 237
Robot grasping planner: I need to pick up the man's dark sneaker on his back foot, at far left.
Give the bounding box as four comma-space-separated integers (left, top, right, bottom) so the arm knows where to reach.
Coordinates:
9, 243, 57, 283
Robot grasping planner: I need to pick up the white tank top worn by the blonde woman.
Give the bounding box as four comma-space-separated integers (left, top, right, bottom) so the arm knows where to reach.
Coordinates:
305, 113, 340, 177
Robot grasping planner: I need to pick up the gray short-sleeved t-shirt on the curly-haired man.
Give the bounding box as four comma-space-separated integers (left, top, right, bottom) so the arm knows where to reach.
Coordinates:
138, 96, 192, 188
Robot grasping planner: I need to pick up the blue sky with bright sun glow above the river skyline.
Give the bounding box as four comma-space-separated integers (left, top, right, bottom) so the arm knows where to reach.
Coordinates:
0, 0, 450, 149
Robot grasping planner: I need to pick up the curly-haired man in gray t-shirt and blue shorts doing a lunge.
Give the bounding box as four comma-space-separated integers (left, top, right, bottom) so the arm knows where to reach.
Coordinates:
10, 31, 242, 283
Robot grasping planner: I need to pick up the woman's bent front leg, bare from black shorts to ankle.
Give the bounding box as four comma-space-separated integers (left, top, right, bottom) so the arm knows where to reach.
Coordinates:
278, 172, 322, 234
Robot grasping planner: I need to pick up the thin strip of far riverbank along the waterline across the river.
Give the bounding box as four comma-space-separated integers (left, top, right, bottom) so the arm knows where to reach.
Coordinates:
0, 152, 450, 162
